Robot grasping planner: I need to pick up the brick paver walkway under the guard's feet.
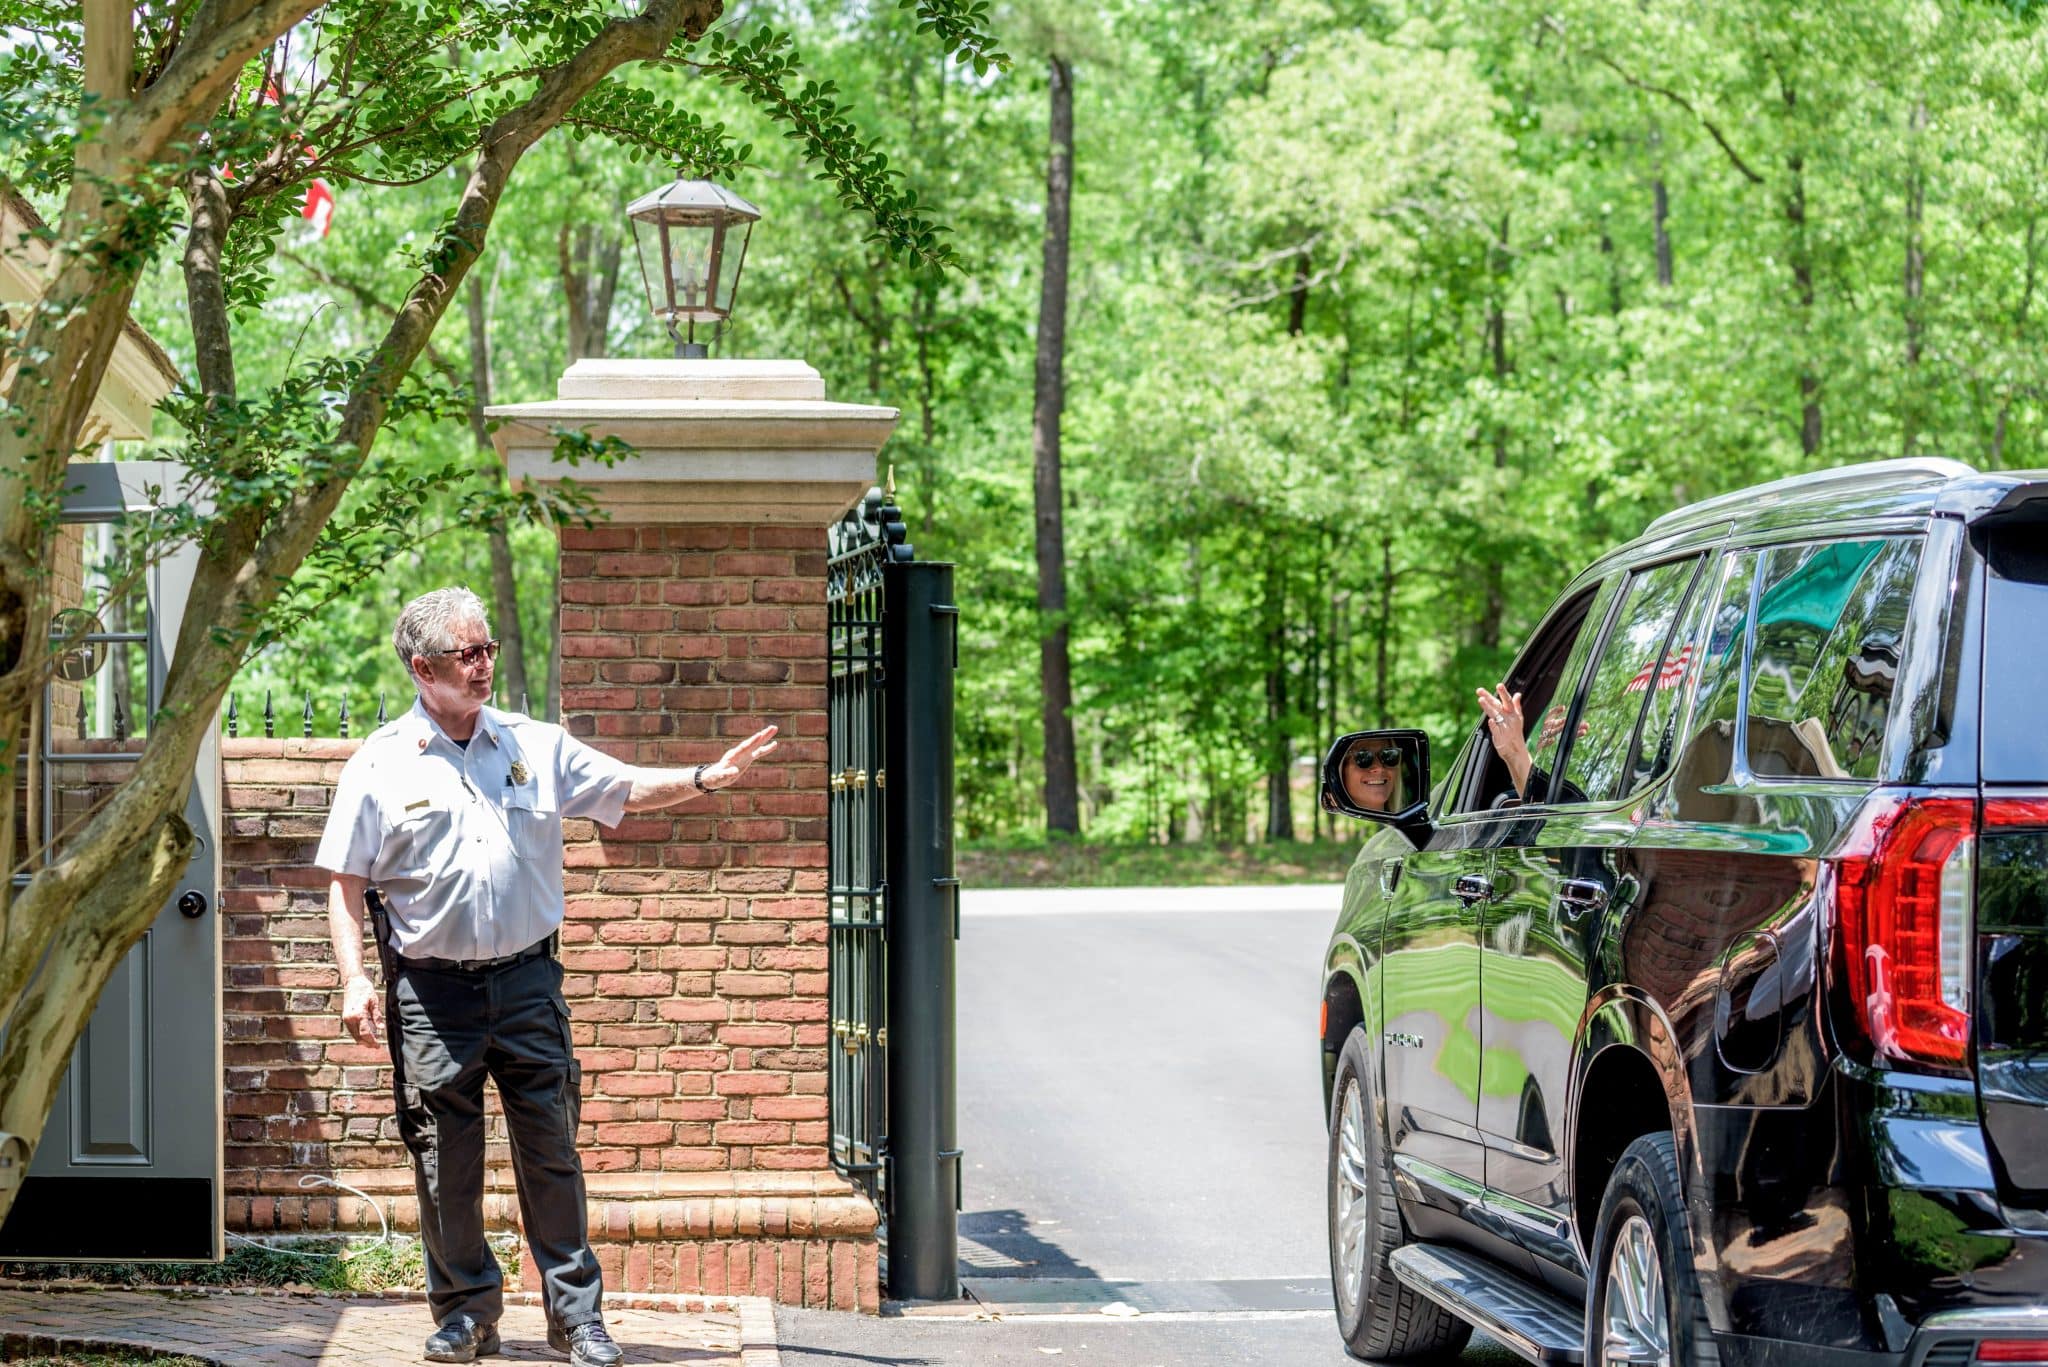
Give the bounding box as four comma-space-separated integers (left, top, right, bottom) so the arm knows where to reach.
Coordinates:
0, 1289, 778, 1367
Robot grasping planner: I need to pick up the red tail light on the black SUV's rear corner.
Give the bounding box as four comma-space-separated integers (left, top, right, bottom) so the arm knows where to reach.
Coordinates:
1829, 797, 1976, 1072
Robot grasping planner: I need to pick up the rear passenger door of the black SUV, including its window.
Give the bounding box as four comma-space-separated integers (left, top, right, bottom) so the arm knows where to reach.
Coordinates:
1479, 555, 1700, 1269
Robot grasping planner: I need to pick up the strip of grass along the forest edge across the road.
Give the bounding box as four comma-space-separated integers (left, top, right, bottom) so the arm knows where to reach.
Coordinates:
954, 840, 1360, 887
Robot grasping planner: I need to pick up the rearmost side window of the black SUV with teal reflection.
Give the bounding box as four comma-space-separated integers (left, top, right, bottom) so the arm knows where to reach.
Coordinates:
1745, 537, 1921, 779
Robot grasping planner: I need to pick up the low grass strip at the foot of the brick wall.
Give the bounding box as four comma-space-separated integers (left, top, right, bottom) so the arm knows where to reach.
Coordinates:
0, 1236, 518, 1291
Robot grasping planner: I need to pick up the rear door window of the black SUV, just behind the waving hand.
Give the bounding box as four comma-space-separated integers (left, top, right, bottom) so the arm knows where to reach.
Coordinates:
1538, 557, 1700, 803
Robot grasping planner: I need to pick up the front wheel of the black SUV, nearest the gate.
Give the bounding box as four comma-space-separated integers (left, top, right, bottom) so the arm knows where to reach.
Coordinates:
1323, 1027, 1473, 1361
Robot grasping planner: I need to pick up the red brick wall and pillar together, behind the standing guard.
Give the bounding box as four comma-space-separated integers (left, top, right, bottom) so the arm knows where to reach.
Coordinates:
221, 527, 879, 1310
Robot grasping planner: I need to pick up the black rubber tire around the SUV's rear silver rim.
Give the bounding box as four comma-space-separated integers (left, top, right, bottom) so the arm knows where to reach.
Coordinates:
1585, 1131, 1720, 1367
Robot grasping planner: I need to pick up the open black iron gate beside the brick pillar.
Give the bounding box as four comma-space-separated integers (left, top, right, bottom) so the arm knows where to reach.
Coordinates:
825, 490, 961, 1299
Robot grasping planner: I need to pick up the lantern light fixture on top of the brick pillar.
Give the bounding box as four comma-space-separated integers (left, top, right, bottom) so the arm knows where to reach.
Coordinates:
627, 176, 762, 359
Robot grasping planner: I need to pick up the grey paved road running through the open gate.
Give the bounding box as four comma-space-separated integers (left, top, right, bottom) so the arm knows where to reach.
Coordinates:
776, 885, 1516, 1367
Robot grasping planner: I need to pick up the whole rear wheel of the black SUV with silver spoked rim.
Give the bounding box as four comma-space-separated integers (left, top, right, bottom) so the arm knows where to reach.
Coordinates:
1585, 1133, 1720, 1367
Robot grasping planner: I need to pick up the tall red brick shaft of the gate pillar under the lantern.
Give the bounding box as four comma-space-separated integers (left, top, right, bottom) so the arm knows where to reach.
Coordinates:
561, 525, 829, 1170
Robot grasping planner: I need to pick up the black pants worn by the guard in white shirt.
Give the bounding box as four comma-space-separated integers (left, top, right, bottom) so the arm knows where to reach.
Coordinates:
385, 955, 604, 1328
